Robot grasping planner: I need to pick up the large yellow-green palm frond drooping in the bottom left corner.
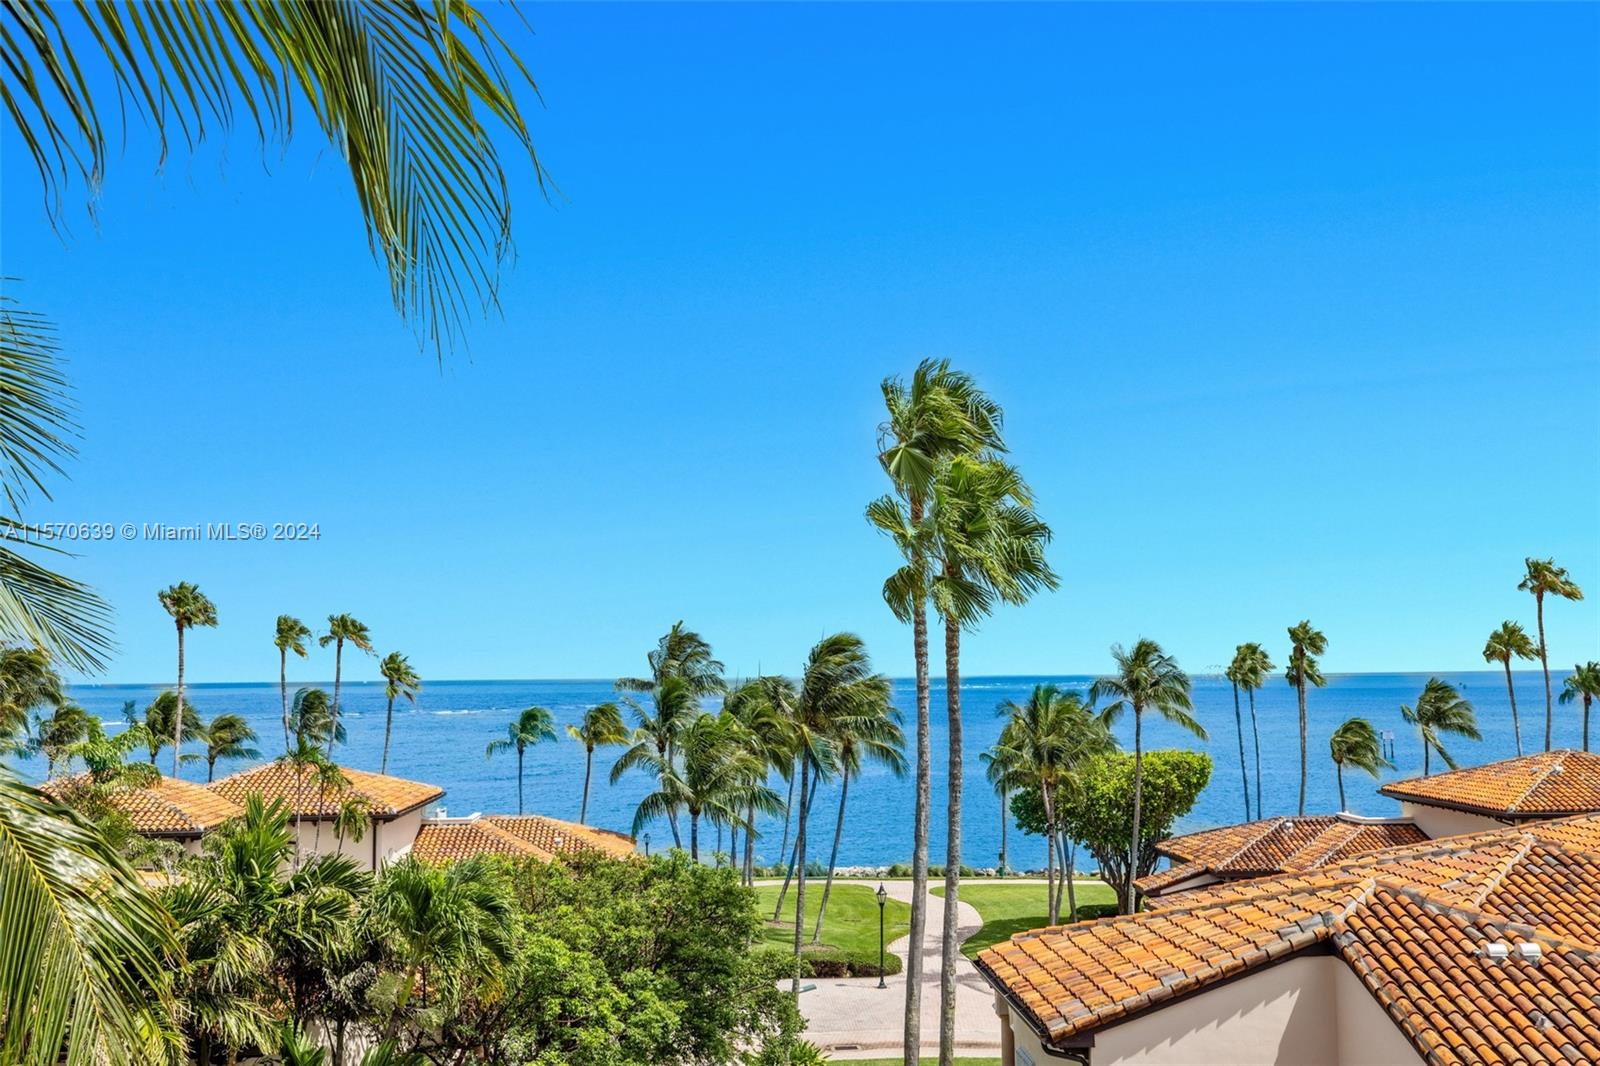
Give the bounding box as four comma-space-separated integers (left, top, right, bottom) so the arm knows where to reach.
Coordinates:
0, 770, 179, 1066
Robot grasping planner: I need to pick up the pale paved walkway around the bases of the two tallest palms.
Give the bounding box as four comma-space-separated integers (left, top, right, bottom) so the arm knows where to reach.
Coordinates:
761, 880, 1000, 1061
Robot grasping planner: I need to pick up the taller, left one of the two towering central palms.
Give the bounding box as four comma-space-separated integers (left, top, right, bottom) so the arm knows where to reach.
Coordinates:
870, 359, 1005, 1066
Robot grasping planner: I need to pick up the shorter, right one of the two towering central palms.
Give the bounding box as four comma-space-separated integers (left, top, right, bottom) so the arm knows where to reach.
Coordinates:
928, 456, 1056, 1066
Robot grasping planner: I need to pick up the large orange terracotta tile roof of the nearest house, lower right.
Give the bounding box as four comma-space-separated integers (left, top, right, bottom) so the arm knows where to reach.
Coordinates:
978, 816, 1600, 1066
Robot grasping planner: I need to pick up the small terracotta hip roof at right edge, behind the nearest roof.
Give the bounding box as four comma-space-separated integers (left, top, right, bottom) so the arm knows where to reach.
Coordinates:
1378, 751, 1600, 821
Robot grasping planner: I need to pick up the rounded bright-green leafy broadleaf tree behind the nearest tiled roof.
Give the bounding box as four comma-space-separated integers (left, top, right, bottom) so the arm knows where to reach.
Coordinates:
1056, 751, 1211, 914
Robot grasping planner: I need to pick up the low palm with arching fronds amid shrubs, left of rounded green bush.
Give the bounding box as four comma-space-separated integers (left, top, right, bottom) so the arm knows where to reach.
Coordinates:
368, 856, 515, 1040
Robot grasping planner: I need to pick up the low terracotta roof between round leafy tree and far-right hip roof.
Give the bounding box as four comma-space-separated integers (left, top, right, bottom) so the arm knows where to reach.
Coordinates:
1134, 815, 1427, 896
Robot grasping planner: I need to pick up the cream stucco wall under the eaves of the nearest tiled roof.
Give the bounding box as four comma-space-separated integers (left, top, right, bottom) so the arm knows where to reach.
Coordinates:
1002, 956, 1421, 1066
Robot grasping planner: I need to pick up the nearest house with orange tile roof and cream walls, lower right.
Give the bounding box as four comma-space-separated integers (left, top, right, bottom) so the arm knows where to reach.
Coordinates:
976, 815, 1600, 1066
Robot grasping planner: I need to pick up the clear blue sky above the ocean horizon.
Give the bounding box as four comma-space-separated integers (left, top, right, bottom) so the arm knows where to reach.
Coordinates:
0, 5, 1600, 682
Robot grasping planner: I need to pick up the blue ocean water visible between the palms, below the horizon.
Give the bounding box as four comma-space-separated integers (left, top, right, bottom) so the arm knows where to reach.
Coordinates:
12, 671, 1580, 868
